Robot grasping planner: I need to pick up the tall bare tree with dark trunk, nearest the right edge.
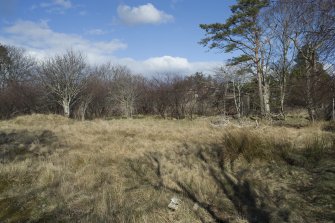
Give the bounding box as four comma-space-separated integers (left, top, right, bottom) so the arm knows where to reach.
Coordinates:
288, 0, 335, 121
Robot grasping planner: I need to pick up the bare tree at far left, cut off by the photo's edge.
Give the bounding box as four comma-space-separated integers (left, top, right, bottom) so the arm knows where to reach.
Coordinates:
0, 45, 39, 117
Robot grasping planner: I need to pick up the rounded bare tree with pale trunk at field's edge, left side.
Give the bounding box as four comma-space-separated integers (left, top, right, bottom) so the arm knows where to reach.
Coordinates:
40, 50, 87, 117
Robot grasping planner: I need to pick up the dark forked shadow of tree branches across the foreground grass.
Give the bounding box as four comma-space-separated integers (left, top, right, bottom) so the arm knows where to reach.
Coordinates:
127, 145, 270, 223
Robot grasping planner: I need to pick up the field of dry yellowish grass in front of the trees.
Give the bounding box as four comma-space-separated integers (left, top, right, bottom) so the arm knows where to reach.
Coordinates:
0, 115, 335, 223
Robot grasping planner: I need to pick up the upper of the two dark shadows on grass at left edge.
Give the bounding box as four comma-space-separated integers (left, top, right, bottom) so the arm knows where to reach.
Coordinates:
0, 130, 57, 163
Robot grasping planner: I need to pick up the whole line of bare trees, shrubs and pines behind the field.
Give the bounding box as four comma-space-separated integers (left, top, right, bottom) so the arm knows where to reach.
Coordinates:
0, 0, 335, 121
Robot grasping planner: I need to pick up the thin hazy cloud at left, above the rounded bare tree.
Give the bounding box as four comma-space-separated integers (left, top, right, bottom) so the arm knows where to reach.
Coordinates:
0, 20, 127, 62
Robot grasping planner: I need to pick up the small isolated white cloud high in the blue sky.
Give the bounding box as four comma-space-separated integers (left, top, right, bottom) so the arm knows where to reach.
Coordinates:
117, 3, 173, 25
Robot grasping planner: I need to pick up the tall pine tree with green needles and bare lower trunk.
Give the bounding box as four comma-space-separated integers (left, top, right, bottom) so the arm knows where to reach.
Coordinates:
200, 0, 270, 115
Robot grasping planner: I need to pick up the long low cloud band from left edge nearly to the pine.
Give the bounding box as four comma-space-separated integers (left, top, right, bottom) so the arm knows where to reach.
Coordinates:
0, 20, 221, 76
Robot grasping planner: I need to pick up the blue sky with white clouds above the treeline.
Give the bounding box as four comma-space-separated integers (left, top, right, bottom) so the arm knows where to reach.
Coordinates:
0, 0, 235, 75
